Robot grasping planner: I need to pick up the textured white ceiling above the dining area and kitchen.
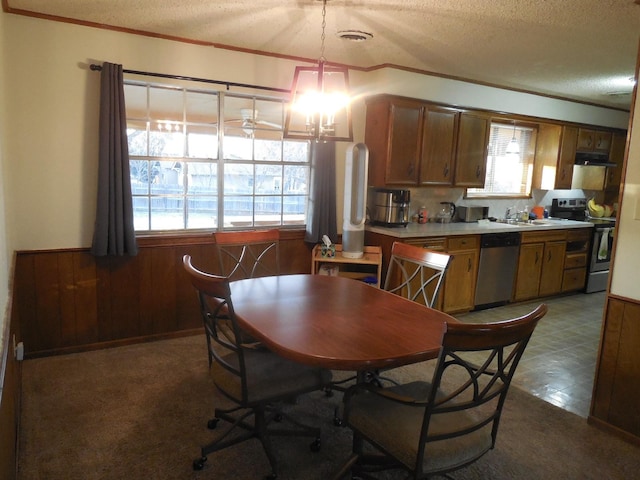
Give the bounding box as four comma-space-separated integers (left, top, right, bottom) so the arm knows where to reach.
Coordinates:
4, 0, 640, 110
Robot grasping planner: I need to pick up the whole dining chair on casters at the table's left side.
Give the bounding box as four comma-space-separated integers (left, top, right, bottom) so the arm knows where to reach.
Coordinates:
182, 255, 331, 478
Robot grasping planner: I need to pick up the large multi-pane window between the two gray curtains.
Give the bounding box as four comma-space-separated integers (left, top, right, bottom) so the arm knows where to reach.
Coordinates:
125, 81, 310, 232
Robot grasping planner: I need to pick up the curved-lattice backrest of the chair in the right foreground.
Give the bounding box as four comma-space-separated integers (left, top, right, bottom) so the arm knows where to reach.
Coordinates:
417, 304, 547, 468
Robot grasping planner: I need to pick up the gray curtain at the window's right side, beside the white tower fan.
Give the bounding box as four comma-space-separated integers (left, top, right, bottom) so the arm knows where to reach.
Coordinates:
304, 142, 338, 243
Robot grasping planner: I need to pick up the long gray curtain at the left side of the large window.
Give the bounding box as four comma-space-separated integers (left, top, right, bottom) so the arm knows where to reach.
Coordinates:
91, 62, 138, 256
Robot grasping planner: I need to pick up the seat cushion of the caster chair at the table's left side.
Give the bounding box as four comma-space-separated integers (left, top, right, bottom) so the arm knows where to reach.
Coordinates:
211, 349, 331, 404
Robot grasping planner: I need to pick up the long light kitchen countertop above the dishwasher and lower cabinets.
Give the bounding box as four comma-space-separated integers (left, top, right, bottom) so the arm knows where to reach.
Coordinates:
366, 219, 593, 238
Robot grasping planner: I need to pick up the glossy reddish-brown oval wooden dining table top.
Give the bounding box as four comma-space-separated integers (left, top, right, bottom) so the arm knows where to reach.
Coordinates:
231, 274, 457, 371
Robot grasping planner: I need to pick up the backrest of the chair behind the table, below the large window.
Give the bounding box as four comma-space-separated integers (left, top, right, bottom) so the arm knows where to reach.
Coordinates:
213, 229, 280, 280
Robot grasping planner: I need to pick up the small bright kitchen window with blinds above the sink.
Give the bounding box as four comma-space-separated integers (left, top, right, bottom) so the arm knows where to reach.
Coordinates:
467, 122, 537, 198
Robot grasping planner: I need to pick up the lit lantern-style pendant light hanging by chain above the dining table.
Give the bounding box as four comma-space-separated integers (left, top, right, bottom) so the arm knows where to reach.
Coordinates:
284, 0, 353, 142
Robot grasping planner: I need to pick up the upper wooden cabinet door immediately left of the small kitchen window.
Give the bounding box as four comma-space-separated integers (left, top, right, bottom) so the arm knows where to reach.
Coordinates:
454, 112, 489, 188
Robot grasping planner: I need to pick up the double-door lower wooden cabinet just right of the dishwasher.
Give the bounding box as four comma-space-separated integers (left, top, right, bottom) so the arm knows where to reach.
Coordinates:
513, 230, 567, 301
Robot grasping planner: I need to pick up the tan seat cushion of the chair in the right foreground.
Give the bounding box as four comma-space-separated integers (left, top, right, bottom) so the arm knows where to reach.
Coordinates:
347, 382, 493, 474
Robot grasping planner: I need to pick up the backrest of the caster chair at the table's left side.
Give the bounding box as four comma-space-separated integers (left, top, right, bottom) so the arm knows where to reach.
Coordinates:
182, 255, 248, 402
